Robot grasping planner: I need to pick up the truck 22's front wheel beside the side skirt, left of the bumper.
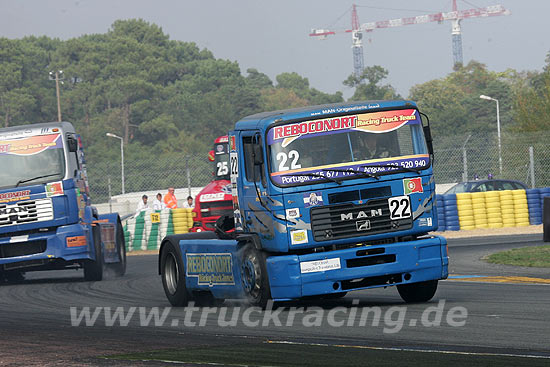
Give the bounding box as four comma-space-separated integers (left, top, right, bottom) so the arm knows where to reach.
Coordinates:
241, 244, 271, 308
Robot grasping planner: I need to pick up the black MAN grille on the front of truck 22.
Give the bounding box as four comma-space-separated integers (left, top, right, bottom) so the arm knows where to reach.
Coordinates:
311, 198, 412, 242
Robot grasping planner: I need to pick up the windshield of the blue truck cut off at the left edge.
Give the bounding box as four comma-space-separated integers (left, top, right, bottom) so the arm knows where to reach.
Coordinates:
0, 134, 65, 188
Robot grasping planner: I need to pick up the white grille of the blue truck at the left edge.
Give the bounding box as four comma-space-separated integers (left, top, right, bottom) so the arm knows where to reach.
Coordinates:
0, 199, 53, 227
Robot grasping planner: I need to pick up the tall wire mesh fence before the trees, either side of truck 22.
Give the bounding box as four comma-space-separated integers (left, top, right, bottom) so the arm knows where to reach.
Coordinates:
88, 132, 550, 203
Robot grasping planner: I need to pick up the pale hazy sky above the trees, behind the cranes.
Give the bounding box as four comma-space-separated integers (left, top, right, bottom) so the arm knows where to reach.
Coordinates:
0, 0, 550, 97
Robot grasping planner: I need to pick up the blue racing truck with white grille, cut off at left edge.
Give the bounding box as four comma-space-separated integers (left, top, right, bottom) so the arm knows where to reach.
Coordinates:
0, 122, 126, 281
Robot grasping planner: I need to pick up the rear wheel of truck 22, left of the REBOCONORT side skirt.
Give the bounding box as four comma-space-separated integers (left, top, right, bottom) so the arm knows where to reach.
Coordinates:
160, 240, 192, 307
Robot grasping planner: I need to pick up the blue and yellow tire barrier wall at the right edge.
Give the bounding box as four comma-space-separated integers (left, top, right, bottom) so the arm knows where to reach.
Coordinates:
436, 188, 550, 231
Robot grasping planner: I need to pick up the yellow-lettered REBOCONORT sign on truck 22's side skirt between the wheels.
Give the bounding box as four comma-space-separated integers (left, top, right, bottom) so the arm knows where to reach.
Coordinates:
185, 253, 235, 287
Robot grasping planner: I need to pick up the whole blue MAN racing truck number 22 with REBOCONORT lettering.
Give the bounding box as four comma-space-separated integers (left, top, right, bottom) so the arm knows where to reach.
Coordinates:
159, 101, 448, 307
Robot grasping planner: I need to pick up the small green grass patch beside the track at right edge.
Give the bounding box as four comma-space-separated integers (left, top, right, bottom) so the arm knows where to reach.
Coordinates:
485, 245, 550, 268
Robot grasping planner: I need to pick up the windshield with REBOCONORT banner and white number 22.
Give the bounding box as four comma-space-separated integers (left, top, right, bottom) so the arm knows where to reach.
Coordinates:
267, 109, 429, 185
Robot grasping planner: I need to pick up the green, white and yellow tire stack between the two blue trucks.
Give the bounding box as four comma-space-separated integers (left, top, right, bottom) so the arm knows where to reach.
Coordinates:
124, 208, 193, 252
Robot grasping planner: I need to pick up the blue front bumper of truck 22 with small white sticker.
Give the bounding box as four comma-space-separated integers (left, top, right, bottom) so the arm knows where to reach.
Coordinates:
267, 236, 449, 300
